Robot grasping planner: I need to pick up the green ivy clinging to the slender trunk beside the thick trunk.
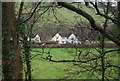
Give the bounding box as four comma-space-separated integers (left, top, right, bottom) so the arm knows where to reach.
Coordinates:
19, 17, 31, 81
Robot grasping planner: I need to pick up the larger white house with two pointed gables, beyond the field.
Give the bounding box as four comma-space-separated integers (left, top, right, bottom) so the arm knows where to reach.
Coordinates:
51, 33, 81, 44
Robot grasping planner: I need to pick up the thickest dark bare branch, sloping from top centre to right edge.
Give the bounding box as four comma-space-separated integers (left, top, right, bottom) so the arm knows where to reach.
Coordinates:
58, 2, 120, 46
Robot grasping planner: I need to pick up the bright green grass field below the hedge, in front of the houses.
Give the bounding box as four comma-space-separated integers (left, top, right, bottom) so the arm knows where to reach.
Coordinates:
29, 48, 118, 79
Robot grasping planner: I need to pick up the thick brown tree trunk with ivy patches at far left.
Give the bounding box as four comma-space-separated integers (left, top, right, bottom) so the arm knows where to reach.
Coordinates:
2, 2, 23, 81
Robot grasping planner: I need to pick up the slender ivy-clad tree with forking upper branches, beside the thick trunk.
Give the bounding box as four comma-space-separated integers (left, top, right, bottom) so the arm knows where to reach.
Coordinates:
18, 2, 49, 81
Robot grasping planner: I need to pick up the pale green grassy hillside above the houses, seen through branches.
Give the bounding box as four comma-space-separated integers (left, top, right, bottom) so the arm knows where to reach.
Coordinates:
16, 3, 109, 32
